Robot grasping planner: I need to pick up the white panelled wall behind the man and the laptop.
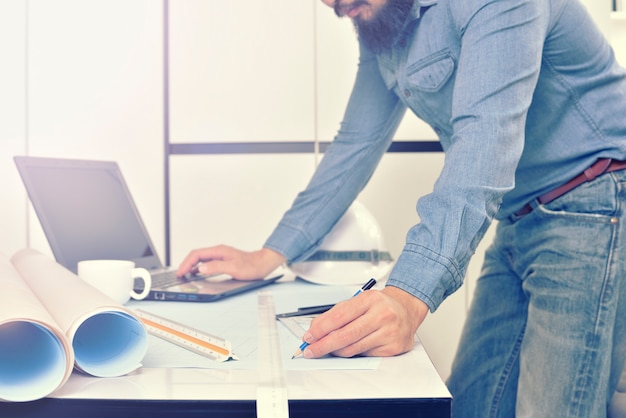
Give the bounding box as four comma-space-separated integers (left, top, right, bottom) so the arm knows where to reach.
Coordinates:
0, 0, 626, 377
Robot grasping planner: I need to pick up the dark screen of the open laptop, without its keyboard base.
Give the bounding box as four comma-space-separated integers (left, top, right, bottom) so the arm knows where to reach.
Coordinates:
15, 157, 162, 272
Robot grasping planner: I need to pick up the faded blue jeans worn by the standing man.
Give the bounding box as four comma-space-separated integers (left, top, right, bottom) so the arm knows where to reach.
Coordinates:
448, 171, 626, 418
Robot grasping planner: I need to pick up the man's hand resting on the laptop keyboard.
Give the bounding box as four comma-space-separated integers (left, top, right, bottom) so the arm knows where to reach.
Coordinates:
177, 245, 285, 280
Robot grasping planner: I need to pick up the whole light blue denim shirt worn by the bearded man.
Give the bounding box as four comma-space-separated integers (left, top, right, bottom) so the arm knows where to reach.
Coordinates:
265, 0, 626, 311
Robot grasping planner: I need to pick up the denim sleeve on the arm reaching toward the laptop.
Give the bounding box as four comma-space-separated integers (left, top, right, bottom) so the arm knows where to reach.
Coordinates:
264, 43, 406, 262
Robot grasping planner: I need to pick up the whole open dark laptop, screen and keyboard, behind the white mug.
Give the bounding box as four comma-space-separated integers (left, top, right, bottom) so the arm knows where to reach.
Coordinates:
14, 156, 281, 302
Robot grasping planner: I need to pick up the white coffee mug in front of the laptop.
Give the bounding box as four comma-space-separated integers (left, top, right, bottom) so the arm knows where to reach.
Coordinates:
78, 260, 152, 304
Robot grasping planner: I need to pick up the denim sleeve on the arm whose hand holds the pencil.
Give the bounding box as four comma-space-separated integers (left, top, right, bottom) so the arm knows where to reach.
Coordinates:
388, 0, 549, 311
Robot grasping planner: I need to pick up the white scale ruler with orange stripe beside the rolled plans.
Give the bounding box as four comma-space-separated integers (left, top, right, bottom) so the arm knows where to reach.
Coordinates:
134, 309, 236, 362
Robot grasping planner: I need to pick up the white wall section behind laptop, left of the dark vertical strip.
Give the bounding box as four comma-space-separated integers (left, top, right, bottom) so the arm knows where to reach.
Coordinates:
0, 0, 163, 262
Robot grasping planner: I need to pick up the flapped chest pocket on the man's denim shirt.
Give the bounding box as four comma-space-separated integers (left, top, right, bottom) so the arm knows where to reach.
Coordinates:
406, 50, 455, 92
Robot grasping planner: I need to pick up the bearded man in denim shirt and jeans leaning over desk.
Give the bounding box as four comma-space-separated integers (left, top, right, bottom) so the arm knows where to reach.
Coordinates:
179, 0, 626, 418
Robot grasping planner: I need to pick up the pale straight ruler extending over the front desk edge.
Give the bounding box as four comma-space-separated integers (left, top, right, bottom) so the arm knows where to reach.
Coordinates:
256, 290, 289, 418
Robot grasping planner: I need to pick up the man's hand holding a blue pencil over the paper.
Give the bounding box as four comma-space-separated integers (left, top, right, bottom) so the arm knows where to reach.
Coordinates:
304, 286, 428, 358
